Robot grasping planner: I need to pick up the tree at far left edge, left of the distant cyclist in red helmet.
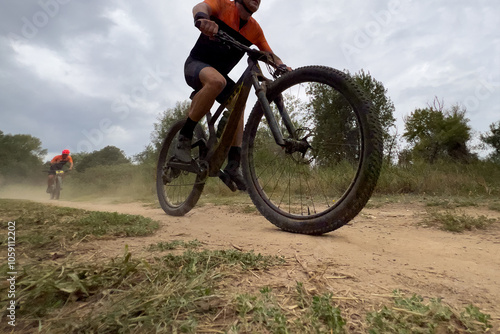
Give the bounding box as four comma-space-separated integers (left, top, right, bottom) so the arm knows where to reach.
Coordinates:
0, 131, 47, 181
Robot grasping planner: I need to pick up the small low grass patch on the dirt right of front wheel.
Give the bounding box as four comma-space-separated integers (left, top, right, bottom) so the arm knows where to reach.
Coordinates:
421, 211, 495, 232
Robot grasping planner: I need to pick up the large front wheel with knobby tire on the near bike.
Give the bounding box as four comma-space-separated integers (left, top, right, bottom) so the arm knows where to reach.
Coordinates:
242, 66, 382, 234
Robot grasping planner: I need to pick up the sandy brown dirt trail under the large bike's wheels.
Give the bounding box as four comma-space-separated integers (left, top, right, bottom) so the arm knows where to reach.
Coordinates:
0, 190, 500, 333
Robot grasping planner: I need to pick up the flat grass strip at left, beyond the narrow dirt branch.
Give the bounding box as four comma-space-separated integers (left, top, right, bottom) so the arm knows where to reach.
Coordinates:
0, 199, 159, 257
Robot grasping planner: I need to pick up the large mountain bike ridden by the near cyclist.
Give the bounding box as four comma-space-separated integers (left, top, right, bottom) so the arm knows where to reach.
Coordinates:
156, 31, 382, 235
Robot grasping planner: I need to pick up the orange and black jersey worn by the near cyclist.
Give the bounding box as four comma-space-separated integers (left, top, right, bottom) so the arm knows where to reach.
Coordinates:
190, 0, 272, 75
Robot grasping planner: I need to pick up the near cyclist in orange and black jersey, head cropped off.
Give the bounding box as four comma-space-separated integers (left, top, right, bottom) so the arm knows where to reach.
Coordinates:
175, 0, 285, 190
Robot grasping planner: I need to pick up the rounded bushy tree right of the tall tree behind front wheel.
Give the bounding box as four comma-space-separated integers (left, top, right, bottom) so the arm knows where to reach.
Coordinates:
403, 99, 472, 163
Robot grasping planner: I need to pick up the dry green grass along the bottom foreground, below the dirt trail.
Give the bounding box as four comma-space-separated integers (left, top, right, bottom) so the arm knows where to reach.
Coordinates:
0, 242, 491, 334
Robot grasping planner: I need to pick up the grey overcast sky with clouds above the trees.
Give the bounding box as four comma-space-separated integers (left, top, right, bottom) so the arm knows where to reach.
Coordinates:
0, 0, 500, 162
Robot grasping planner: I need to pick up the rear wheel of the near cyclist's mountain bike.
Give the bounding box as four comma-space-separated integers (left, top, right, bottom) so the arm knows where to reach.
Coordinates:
156, 121, 205, 216
